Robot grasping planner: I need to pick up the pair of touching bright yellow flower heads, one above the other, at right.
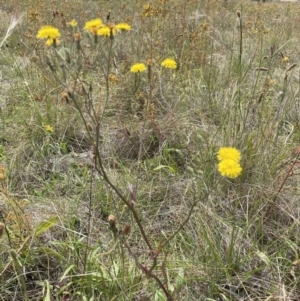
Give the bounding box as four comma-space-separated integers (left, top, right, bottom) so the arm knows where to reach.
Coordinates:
217, 147, 242, 179
